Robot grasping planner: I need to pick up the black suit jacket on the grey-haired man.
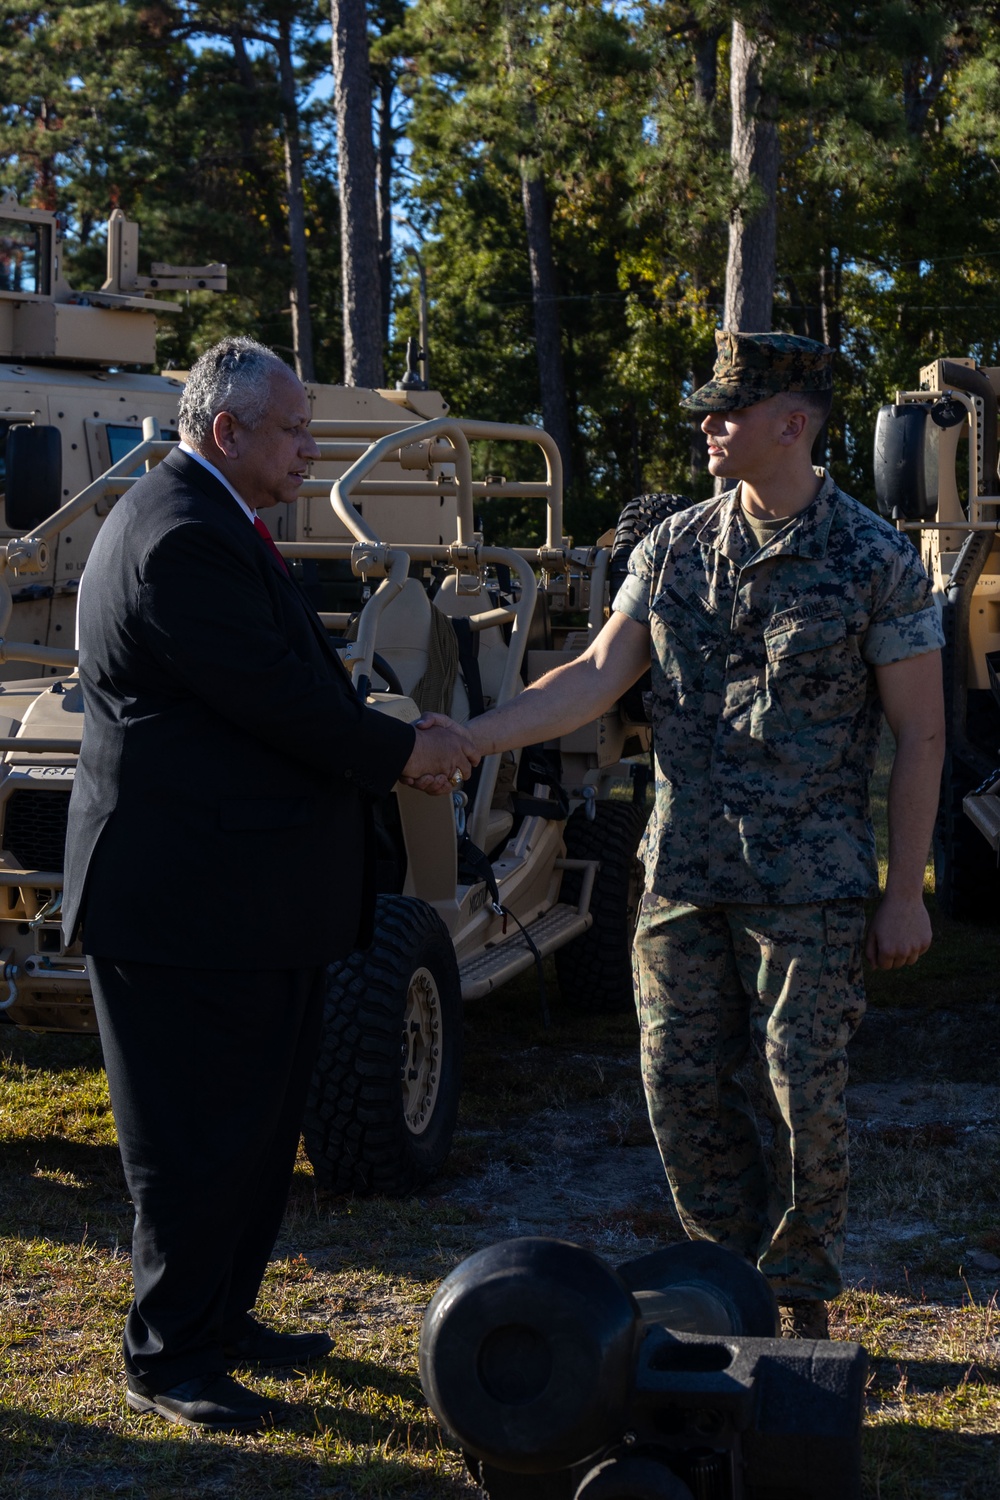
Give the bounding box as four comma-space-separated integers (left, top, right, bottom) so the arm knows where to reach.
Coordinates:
63, 452, 415, 969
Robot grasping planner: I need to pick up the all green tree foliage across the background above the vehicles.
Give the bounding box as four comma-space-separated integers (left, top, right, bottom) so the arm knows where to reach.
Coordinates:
0, 0, 1000, 540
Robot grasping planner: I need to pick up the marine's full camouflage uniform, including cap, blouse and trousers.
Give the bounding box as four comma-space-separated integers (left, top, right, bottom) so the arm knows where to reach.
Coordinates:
615, 335, 943, 1302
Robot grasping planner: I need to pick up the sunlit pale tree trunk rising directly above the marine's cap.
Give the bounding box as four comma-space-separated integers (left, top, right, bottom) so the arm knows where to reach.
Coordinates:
724, 21, 778, 333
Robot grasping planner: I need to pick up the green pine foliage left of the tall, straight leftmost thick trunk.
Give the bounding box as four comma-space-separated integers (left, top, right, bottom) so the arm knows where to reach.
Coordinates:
0, 0, 342, 380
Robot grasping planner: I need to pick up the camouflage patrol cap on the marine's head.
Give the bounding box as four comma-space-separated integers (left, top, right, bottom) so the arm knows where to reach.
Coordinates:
681, 329, 834, 411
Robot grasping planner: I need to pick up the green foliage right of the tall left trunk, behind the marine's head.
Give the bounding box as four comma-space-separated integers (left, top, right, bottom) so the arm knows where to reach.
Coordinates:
399, 0, 1000, 522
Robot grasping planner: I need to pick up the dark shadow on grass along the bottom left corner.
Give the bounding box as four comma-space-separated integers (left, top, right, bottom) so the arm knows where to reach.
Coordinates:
0, 1404, 469, 1500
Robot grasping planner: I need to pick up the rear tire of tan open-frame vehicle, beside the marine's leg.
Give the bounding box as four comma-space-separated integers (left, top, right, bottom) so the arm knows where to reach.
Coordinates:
556, 803, 646, 1013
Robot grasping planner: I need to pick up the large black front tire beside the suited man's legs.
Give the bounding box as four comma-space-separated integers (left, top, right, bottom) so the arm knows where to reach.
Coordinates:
303, 896, 462, 1197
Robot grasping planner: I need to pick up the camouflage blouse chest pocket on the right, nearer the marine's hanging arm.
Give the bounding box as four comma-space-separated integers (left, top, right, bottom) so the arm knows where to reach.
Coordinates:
765, 611, 865, 731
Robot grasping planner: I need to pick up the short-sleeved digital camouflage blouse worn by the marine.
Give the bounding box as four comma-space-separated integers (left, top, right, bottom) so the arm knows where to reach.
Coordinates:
615, 471, 943, 906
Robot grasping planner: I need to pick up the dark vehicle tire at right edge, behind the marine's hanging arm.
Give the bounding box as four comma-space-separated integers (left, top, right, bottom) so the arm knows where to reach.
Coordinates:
934, 753, 1000, 924
